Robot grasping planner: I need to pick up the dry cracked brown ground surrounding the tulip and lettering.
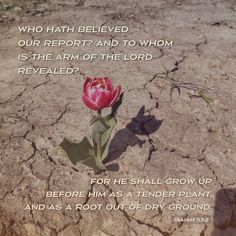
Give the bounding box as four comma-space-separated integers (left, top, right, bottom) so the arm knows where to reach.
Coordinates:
0, 0, 236, 236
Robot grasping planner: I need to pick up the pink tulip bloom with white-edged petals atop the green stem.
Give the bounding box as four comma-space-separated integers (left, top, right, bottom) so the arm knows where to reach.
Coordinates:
82, 77, 121, 110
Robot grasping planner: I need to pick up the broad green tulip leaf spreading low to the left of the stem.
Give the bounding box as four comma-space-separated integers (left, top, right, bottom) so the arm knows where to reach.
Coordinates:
60, 137, 106, 170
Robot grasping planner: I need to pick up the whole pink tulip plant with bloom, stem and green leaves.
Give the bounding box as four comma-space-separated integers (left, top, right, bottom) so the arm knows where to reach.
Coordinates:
60, 78, 123, 170
